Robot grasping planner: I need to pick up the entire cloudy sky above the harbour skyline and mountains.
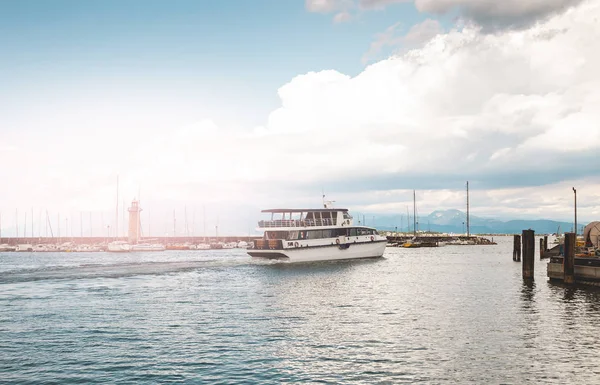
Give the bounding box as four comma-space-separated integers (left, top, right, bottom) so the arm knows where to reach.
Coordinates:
0, 0, 600, 236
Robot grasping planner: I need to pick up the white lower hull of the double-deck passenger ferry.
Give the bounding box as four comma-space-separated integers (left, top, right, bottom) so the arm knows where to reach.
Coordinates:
248, 240, 387, 262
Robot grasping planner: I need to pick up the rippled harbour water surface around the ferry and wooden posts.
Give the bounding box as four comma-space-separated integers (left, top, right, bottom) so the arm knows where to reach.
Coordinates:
0, 238, 600, 384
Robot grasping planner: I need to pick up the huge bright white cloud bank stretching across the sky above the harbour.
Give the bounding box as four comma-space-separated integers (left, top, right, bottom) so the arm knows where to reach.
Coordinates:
0, 2, 600, 232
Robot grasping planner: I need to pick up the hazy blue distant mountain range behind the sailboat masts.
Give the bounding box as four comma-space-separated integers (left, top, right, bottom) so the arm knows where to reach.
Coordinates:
367, 210, 573, 234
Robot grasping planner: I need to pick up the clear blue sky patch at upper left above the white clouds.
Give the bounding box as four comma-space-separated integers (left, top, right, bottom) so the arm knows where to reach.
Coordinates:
0, 0, 424, 125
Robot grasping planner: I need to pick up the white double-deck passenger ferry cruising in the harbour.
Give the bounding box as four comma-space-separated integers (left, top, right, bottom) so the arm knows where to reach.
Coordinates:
248, 208, 387, 262
